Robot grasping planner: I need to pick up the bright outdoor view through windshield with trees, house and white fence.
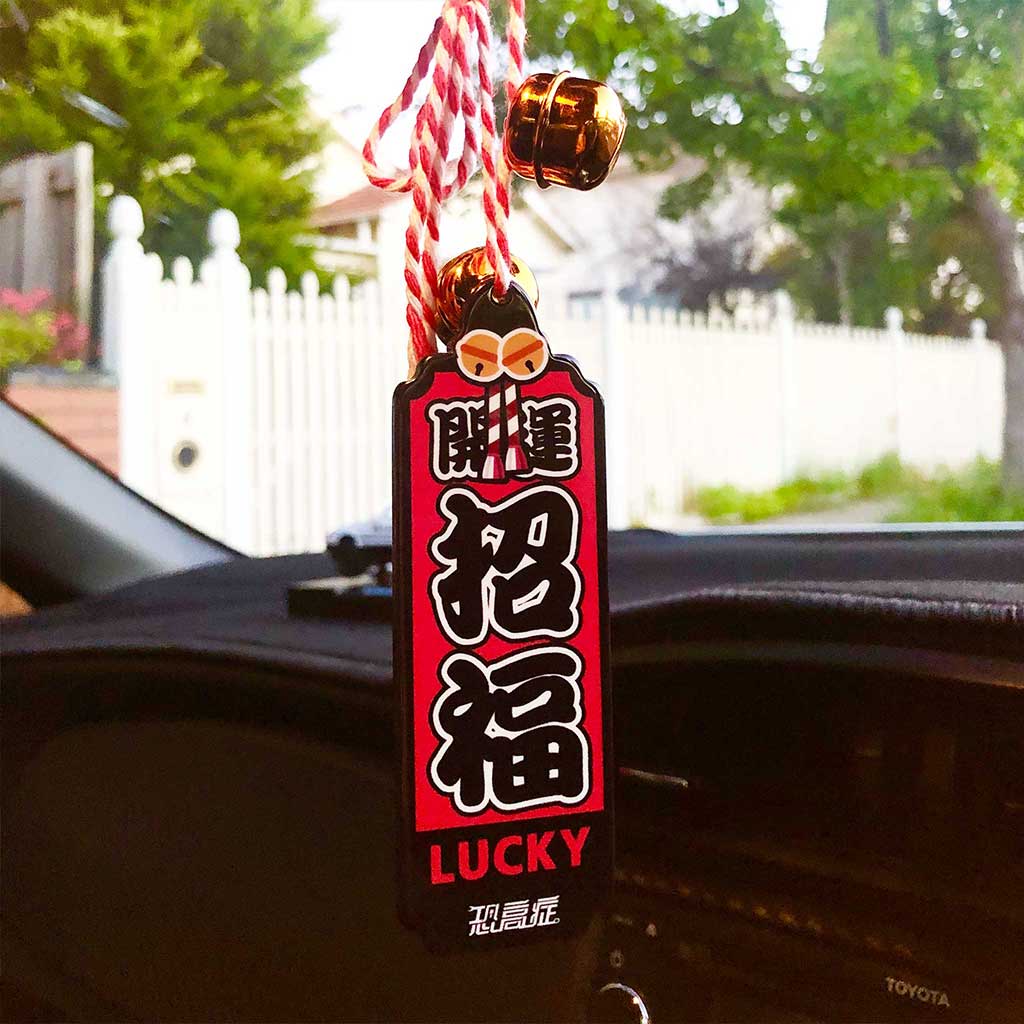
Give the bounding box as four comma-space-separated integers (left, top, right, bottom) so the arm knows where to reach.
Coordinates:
0, 0, 1024, 554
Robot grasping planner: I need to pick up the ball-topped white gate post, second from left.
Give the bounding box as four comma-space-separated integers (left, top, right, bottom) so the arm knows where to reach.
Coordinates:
200, 210, 257, 554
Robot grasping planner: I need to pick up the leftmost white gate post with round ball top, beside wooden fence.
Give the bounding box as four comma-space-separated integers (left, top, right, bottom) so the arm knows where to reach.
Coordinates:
101, 196, 159, 499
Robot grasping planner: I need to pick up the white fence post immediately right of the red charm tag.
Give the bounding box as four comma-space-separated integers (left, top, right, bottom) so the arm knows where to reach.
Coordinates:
601, 268, 630, 529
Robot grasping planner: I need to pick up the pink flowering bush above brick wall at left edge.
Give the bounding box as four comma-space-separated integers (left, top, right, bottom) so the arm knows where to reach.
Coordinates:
0, 288, 89, 373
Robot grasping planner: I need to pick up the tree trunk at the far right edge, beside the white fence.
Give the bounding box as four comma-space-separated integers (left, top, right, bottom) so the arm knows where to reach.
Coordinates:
968, 186, 1024, 492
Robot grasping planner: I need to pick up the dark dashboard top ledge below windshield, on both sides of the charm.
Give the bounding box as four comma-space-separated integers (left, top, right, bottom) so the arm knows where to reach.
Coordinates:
4, 528, 1024, 682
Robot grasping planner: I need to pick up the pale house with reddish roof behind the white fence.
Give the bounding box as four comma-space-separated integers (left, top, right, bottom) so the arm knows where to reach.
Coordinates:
309, 112, 777, 302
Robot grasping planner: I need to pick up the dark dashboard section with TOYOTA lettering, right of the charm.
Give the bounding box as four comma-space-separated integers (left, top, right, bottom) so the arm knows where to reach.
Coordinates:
598, 650, 1024, 1021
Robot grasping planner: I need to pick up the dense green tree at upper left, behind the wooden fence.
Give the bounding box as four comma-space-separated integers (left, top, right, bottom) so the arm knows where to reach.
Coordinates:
0, 0, 330, 280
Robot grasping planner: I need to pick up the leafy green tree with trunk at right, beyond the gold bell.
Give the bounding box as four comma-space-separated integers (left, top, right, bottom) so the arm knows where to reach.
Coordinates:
520, 0, 1024, 488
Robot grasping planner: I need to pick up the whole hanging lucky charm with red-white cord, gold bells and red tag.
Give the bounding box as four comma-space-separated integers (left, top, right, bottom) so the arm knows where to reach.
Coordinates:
362, 0, 625, 948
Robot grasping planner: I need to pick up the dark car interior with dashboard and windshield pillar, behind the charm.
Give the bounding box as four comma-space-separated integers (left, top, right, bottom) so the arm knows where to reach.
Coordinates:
0, 395, 1024, 1022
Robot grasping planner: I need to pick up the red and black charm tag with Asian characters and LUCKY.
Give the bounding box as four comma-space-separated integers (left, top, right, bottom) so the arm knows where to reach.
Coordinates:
393, 285, 613, 948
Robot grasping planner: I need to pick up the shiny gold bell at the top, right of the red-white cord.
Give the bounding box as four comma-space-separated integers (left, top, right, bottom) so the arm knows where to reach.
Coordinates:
504, 71, 626, 191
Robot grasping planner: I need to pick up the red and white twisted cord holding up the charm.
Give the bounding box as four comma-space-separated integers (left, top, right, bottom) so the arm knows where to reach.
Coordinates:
362, 0, 525, 367
